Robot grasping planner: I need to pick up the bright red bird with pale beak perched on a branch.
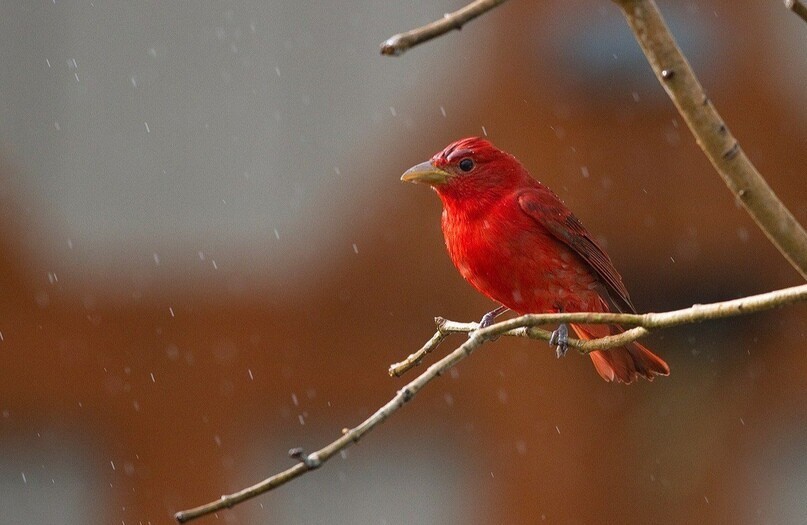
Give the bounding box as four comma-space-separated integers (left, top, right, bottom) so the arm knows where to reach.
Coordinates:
401, 137, 670, 383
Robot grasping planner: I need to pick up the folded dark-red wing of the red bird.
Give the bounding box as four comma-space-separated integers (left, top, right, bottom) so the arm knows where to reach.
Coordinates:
518, 188, 636, 313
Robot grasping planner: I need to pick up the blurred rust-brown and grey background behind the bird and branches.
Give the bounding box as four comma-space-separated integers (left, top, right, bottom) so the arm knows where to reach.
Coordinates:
0, 0, 807, 525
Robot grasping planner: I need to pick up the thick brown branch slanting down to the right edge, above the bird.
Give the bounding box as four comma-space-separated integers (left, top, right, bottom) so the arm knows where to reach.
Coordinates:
614, 0, 807, 279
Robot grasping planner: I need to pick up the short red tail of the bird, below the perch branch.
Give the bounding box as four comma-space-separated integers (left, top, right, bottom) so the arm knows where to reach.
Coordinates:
570, 324, 670, 384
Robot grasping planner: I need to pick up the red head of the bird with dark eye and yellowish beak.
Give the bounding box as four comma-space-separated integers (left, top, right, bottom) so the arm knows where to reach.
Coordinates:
401, 137, 529, 203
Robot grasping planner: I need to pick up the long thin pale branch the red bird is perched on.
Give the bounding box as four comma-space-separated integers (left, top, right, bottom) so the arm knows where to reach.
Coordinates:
175, 284, 807, 523
